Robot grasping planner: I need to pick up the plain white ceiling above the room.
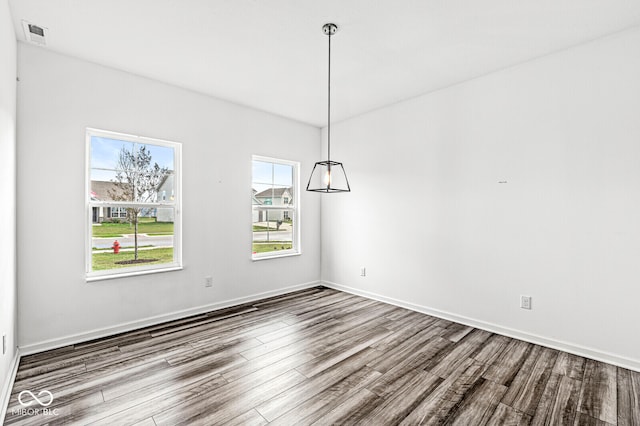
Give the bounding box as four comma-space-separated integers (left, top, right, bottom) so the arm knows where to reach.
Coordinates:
10, 0, 640, 126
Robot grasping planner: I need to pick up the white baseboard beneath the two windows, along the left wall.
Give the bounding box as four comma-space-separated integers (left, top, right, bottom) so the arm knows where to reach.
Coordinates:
20, 281, 321, 356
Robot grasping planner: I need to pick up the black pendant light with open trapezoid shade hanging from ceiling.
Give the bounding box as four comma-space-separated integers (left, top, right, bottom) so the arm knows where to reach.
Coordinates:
307, 24, 351, 193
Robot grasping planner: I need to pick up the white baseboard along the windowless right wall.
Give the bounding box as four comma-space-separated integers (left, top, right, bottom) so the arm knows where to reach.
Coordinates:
322, 281, 640, 372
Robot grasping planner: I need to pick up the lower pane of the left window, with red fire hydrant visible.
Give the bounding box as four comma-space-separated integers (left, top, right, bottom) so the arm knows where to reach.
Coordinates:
91, 207, 176, 271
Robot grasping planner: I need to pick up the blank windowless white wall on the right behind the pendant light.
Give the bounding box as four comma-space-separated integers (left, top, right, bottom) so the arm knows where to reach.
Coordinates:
322, 28, 640, 369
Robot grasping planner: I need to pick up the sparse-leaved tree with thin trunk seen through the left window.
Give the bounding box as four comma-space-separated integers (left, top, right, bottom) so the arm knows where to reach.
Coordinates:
109, 145, 169, 260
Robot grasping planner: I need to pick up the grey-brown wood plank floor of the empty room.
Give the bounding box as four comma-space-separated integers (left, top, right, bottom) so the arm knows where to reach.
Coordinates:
5, 287, 640, 426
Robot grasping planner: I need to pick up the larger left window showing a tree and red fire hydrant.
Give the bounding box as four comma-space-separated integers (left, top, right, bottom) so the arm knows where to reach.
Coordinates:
86, 129, 182, 280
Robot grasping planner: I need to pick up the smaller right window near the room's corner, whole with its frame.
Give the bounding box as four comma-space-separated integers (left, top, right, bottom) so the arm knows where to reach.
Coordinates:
251, 156, 300, 260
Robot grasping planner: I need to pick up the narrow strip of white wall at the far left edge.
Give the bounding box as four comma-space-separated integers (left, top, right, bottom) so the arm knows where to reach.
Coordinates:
0, 0, 17, 416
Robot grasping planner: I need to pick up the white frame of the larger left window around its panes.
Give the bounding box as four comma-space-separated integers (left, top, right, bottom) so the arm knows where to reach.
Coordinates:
85, 127, 183, 282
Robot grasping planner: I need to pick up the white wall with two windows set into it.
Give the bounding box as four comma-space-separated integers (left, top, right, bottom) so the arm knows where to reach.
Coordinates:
18, 43, 320, 351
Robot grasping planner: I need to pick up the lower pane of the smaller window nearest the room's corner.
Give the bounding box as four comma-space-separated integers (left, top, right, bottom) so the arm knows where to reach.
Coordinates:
253, 208, 295, 254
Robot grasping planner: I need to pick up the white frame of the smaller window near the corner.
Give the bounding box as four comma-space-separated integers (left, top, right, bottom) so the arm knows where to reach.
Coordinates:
249, 155, 302, 261
